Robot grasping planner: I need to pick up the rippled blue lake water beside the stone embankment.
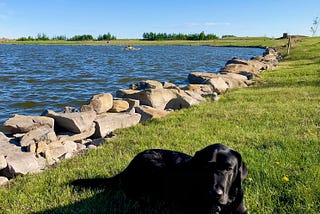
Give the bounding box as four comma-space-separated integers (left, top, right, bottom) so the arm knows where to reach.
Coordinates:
0, 45, 264, 122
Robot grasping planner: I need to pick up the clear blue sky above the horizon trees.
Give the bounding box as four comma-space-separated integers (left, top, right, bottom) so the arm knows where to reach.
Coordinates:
0, 0, 320, 39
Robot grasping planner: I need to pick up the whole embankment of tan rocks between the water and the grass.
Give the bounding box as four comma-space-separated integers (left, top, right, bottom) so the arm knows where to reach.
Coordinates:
0, 48, 280, 185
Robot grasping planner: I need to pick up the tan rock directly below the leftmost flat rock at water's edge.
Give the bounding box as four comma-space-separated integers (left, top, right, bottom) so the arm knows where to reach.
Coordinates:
20, 125, 58, 147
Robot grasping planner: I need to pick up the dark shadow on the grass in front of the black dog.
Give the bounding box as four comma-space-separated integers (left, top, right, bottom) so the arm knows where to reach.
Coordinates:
34, 186, 181, 214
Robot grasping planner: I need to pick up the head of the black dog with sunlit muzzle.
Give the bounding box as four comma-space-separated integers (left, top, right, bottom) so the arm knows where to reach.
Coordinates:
192, 144, 247, 205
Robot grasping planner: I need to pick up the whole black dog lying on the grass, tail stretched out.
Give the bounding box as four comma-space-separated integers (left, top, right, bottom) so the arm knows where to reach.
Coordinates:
72, 144, 247, 213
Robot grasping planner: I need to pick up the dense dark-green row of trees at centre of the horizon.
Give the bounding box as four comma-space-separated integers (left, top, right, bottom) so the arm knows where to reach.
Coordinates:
142, 31, 219, 41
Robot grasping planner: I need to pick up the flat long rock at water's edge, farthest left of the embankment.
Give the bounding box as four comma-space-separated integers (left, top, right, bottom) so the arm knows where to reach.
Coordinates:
3, 114, 54, 134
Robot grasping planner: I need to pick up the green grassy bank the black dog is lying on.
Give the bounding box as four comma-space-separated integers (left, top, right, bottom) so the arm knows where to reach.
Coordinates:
0, 38, 320, 214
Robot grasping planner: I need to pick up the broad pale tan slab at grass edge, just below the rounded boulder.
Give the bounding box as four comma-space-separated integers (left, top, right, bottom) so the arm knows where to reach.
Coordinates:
94, 113, 141, 138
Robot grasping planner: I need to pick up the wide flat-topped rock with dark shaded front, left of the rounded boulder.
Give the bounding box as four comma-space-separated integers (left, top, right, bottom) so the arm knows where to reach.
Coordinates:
46, 110, 96, 133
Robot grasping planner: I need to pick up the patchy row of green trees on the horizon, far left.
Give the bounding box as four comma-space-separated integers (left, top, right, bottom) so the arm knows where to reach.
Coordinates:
17, 33, 117, 41
